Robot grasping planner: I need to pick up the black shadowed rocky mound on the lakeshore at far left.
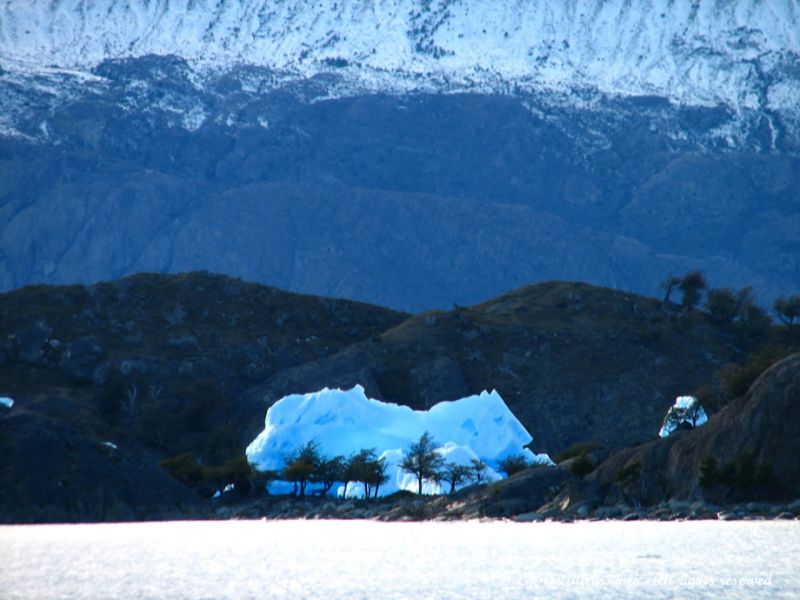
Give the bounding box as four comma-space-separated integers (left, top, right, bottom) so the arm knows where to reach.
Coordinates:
0, 408, 198, 523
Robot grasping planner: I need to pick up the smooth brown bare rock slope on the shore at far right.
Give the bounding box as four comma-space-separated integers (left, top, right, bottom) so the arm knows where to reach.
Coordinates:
590, 354, 800, 505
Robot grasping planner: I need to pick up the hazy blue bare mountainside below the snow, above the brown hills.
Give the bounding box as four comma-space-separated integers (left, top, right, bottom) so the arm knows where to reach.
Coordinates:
0, 57, 800, 310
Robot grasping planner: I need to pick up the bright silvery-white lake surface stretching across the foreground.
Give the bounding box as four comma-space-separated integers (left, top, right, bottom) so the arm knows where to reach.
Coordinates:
0, 521, 800, 600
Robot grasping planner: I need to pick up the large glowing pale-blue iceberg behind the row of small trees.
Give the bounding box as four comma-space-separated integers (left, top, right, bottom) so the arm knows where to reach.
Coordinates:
247, 385, 552, 496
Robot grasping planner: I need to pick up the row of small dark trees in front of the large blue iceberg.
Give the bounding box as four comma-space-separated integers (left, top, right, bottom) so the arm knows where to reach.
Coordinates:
271, 431, 531, 498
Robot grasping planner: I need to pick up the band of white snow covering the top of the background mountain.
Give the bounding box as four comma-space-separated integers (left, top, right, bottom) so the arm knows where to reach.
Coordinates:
0, 0, 800, 108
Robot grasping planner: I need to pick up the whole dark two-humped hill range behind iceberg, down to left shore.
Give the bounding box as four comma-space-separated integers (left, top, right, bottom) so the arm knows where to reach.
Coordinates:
0, 273, 780, 521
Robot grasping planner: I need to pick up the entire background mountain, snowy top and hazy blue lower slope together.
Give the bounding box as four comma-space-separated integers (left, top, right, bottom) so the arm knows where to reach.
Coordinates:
0, 0, 800, 311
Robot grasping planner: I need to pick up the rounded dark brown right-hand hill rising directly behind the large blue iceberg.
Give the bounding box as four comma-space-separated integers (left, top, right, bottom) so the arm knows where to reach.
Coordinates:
245, 282, 760, 453
